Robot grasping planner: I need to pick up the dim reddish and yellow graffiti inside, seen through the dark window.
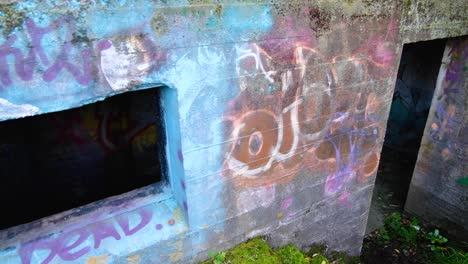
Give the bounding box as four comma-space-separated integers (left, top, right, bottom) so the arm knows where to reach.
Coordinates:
43, 90, 160, 152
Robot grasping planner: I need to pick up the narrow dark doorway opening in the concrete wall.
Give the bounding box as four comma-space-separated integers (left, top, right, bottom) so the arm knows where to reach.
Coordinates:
366, 39, 446, 233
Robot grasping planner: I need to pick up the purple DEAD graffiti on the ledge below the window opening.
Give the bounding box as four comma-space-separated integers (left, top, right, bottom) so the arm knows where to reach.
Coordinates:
19, 208, 177, 264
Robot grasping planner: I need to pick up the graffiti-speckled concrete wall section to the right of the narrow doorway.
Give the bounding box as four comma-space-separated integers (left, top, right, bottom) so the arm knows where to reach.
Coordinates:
405, 37, 468, 240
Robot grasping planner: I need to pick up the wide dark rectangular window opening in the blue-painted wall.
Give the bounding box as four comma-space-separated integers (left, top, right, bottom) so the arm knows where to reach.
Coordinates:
0, 89, 166, 229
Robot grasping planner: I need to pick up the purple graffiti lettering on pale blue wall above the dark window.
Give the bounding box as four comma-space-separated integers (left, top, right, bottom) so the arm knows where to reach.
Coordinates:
0, 17, 110, 89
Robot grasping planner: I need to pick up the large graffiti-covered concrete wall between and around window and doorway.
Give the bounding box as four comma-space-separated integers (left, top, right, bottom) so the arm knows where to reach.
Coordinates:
0, 0, 467, 263
